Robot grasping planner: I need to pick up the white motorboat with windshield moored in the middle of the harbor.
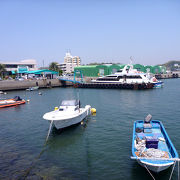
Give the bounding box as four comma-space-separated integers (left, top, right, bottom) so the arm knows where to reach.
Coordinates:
43, 100, 91, 129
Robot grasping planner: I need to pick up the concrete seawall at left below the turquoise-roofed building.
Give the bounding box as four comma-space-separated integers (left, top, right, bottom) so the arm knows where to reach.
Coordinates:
0, 79, 72, 91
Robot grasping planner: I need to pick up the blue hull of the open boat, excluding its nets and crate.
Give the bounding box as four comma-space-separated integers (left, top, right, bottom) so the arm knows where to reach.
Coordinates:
132, 121, 178, 173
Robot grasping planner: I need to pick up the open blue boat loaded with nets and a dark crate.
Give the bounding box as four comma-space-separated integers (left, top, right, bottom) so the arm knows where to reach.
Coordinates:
131, 114, 179, 172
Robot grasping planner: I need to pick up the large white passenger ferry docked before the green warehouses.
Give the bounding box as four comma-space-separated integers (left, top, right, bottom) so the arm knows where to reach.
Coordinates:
92, 64, 163, 87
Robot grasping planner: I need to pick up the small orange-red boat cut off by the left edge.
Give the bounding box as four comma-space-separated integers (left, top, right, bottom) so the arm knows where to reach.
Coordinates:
0, 96, 26, 108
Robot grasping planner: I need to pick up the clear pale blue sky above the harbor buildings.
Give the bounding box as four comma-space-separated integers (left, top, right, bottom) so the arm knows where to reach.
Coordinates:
0, 0, 180, 67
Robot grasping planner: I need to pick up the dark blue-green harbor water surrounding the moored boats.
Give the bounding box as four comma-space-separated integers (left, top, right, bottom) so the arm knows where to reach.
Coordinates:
0, 79, 180, 180
